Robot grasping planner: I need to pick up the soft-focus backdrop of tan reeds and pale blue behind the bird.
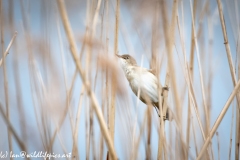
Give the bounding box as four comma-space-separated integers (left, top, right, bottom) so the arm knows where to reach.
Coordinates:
0, 0, 240, 159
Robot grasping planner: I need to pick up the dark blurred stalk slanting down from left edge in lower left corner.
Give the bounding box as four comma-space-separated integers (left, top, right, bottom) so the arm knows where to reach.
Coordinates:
0, 103, 27, 154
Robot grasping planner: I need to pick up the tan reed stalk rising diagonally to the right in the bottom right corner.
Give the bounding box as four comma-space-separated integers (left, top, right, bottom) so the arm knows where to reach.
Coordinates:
197, 81, 240, 160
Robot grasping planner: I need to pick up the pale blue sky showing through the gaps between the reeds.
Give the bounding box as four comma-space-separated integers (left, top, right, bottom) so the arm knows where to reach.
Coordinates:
0, 0, 239, 159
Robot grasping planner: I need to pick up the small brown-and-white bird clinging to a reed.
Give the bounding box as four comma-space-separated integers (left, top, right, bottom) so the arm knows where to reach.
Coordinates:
117, 54, 170, 120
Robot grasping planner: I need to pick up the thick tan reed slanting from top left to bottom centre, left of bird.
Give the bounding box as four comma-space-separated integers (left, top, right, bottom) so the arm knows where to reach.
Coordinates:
57, 0, 117, 159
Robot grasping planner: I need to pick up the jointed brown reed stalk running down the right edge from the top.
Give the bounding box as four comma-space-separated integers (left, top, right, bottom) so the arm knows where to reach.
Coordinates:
217, 0, 240, 159
